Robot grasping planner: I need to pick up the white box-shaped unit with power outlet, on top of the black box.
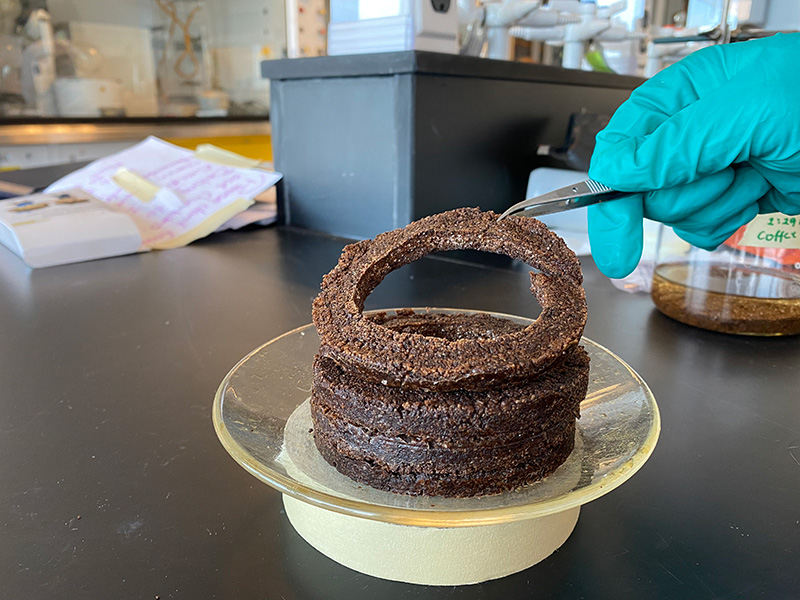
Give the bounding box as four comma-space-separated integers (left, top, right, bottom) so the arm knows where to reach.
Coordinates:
326, 0, 458, 57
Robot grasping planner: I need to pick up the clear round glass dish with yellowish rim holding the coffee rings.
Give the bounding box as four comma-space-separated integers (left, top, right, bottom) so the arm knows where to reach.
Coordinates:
213, 308, 661, 527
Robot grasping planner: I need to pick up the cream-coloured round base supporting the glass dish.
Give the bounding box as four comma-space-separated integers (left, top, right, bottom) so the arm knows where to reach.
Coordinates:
283, 495, 580, 585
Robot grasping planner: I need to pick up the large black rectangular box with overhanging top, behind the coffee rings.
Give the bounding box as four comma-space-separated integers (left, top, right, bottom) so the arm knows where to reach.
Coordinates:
261, 51, 643, 238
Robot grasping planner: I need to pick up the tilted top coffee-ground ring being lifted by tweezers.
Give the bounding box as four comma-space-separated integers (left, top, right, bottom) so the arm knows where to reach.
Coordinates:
312, 208, 586, 391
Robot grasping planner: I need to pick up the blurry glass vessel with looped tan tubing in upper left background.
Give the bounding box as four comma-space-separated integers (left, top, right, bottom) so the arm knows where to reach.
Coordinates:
153, 0, 211, 117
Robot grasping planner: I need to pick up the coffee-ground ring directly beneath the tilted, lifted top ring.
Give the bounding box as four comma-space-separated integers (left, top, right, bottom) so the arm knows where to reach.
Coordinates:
311, 346, 589, 447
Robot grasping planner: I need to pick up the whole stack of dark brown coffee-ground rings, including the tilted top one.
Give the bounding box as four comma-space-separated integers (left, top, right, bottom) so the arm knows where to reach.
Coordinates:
311, 209, 589, 497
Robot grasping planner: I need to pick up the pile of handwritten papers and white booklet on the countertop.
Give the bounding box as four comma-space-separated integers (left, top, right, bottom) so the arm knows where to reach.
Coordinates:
0, 137, 281, 268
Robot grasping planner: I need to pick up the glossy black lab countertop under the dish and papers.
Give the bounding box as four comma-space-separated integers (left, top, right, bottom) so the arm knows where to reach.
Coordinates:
0, 179, 800, 600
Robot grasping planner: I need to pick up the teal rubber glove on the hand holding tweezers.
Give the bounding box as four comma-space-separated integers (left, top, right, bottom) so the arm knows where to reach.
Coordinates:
588, 34, 800, 278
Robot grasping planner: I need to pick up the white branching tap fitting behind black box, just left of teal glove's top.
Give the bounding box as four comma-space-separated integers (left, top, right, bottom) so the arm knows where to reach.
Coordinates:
509, 0, 645, 70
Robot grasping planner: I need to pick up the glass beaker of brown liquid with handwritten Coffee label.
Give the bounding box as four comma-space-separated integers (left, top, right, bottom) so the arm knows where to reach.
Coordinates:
651, 213, 800, 336
